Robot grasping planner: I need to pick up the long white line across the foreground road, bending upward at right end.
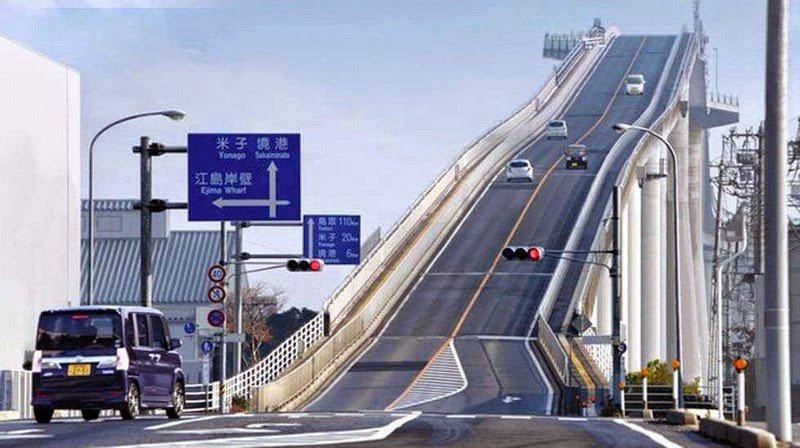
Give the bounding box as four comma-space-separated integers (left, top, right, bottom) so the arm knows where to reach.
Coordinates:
109, 411, 422, 448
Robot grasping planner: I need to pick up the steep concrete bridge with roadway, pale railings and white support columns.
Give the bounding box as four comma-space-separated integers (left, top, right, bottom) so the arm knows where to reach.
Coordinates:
209, 23, 738, 420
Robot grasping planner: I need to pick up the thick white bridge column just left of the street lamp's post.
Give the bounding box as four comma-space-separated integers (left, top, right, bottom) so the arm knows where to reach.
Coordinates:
641, 148, 667, 364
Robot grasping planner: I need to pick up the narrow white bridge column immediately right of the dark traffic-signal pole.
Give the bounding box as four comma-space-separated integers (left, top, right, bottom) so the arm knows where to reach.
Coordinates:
622, 188, 642, 372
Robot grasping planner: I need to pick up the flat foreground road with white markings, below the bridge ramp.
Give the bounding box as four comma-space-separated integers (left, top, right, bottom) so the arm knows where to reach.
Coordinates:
0, 412, 718, 448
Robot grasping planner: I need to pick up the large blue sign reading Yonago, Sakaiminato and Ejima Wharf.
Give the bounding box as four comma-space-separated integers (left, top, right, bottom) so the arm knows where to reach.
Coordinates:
188, 134, 301, 221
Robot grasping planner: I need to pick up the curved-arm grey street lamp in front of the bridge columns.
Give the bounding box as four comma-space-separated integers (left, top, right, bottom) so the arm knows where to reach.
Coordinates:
613, 123, 683, 408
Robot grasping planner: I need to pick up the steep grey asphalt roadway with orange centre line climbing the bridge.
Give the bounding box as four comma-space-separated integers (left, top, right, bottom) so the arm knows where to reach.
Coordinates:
307, 36, 685, 414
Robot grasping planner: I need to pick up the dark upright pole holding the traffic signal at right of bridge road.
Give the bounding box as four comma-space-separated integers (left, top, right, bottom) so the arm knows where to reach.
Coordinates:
611, 185, 623, 403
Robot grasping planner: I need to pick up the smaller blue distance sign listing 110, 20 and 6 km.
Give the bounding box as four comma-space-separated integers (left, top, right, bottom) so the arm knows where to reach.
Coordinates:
303, 215, 361, 264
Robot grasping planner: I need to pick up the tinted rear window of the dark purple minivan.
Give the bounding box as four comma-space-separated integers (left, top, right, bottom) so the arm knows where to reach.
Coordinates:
36, 311, 122, 350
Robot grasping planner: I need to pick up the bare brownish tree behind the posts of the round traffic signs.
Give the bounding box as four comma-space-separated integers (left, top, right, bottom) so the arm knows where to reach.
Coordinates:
225, 283, 286, 369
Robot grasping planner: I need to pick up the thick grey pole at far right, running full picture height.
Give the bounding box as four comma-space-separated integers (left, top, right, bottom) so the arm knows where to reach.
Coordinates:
764, 0, 792, 441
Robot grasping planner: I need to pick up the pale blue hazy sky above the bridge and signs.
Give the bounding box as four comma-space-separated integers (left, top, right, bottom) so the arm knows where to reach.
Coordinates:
0, 0, 800, 309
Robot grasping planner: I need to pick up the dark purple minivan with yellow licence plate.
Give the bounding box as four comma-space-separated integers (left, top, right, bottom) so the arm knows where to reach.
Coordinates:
31, 306, 185, 423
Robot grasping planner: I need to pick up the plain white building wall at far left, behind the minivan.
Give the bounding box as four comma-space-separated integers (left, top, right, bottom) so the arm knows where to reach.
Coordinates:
0, 37, 81, 369
